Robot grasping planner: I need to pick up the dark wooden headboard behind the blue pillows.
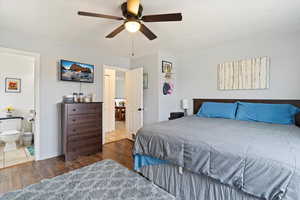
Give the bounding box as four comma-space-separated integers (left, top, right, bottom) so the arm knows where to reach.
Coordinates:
194, 99, 300, 127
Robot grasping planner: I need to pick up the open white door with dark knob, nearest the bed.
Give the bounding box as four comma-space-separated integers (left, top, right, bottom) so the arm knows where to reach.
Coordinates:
125, 68, 144, 134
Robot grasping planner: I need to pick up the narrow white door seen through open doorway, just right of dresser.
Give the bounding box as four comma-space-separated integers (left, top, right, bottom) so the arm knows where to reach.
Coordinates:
103, 69, 116, 133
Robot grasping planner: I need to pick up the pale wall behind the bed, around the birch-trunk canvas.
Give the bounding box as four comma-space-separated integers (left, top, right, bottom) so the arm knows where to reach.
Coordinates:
178, 33, 300, 112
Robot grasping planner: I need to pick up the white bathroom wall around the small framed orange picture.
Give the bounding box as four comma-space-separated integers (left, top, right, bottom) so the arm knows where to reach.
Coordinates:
0, 53, 34, 131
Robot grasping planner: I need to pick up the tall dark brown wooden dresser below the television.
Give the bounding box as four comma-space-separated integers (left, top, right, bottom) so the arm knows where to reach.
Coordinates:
61, 102, 102, 161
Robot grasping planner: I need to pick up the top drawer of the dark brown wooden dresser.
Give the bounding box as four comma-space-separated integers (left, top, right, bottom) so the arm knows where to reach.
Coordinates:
68, 104, 102, 115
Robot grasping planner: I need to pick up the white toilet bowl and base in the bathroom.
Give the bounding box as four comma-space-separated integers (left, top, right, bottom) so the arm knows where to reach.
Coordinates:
0, 130, 21, 152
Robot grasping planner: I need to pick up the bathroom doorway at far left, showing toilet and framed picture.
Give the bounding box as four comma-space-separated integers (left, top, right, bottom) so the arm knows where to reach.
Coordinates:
0, 47, 40, 168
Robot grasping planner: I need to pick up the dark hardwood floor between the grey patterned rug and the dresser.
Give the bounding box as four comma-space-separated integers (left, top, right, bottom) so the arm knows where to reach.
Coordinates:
0, 139, 133, 194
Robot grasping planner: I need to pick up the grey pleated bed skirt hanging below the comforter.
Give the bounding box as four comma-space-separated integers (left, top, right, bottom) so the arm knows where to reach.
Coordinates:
139, 164, 262, 200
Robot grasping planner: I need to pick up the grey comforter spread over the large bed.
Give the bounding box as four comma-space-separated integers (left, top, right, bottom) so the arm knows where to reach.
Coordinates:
134, 116, 300, 200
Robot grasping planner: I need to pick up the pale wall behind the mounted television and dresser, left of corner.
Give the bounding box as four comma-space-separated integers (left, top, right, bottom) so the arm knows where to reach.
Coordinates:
0, 30, 129, 159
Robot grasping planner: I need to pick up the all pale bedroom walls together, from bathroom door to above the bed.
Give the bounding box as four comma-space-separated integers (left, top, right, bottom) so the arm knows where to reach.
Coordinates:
0, 25, 300, 158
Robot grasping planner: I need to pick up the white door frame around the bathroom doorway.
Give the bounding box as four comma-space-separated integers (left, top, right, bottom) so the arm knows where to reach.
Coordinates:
0, 47, 41, 160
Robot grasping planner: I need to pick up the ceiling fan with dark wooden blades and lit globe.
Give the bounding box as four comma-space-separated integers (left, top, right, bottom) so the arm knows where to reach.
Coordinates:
78, 0, 182, 40
